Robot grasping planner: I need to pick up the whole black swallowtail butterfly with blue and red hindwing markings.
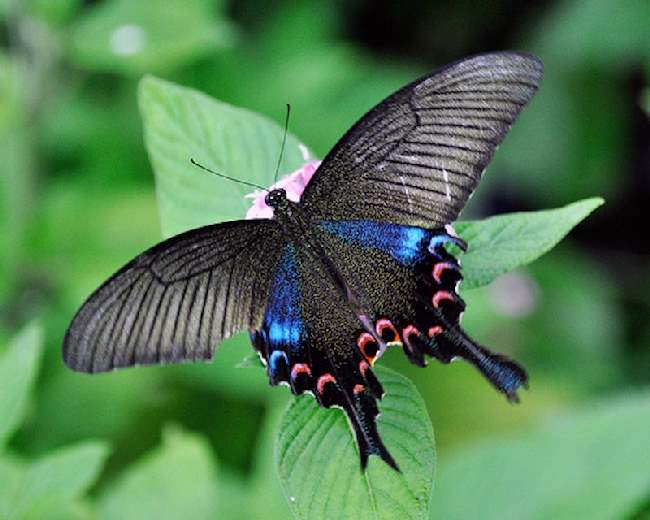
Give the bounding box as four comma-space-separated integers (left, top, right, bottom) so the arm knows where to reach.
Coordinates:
63, 52, 542, 469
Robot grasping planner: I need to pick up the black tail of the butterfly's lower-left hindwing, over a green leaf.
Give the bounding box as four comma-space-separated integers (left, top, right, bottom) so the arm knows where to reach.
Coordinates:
343, 390, 400, 471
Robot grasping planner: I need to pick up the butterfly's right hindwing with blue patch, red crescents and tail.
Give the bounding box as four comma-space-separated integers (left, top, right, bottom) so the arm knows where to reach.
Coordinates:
320, 217, 528, 401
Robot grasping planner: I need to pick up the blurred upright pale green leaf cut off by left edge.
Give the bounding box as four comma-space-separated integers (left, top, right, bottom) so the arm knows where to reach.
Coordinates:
0, 325, 43, 449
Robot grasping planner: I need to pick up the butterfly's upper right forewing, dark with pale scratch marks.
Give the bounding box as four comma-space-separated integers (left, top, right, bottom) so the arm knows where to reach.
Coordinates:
302, 52, 542, 227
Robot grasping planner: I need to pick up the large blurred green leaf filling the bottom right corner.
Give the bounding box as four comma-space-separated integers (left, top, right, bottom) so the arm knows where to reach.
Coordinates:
431, 392, 650, 520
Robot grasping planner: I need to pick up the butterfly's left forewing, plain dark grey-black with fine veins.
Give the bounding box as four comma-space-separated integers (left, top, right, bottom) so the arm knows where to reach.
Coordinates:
63, 220, 283, 372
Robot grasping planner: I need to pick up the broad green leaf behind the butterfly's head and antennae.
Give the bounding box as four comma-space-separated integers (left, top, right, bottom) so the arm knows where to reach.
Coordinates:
139, 77, 303, 236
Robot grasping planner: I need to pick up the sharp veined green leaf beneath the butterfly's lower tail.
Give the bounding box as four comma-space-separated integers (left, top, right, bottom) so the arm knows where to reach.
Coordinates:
277, 367, 436, 520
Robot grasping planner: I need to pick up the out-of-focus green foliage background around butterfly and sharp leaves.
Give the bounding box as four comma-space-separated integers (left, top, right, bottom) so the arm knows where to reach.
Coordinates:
0, 0, 650, 519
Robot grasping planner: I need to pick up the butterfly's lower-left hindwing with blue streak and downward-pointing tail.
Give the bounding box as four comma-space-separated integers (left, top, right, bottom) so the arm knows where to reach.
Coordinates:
251, 242, 397, 469
